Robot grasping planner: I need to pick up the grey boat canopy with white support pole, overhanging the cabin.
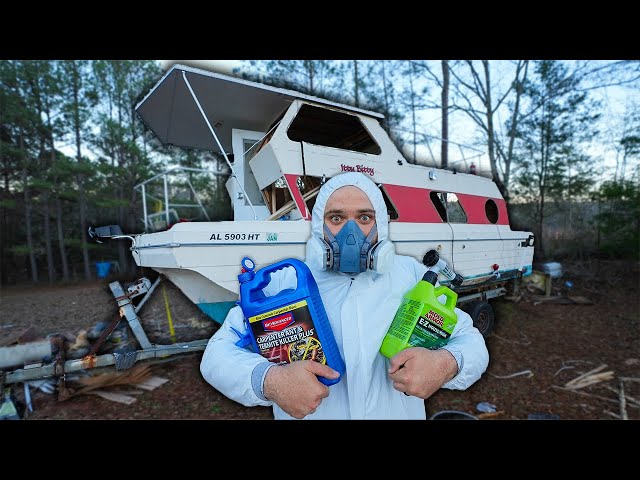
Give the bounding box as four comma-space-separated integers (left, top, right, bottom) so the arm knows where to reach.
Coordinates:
136, 64, 384, 152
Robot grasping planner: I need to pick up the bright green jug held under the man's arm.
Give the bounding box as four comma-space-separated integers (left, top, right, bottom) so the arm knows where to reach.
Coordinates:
380, 271, 458, 358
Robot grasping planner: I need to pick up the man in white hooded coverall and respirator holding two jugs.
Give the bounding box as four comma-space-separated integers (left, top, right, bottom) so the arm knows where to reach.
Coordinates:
200, 172, 489, 419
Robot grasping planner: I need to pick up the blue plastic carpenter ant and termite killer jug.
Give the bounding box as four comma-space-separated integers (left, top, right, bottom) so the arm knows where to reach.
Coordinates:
238, 257, 345, 385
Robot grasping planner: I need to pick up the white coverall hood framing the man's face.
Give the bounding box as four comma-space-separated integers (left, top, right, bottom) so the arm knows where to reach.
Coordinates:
306, 172, 395, 273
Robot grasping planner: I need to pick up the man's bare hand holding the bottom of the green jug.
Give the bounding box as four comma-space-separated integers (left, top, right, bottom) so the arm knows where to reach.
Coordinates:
388, 347, 458, 399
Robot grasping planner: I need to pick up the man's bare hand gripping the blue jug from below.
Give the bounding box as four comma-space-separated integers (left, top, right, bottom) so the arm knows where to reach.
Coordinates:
263, 360, 340, 418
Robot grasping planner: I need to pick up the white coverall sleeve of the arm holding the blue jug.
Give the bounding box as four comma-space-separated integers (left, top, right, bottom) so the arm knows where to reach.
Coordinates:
200, 306, 273, 407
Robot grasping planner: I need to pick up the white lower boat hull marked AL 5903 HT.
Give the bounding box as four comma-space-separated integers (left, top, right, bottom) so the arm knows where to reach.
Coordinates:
132, 220, 533, 324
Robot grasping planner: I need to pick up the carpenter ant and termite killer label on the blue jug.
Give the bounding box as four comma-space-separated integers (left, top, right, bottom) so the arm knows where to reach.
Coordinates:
249, 300, 327, 364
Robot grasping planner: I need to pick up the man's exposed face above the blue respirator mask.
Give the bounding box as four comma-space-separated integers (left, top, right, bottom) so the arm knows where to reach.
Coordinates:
324, 185, 377, 243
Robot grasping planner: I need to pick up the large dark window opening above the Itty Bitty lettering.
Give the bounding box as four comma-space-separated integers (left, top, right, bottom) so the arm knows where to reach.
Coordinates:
287, 104, 381, 155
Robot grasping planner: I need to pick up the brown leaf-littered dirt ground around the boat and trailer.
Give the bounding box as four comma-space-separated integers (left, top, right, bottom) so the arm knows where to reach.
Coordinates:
0, 259, 640, 420
